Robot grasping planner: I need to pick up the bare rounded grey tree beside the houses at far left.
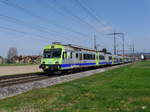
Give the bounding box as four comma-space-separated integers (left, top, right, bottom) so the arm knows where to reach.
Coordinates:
7, 47, 18, 62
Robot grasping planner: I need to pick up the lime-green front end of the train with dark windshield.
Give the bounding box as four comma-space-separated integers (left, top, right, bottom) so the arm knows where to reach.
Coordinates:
39, 44, 63, 72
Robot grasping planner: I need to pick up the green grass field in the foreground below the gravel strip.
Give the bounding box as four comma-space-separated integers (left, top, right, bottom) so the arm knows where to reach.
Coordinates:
0, 61, 150, 112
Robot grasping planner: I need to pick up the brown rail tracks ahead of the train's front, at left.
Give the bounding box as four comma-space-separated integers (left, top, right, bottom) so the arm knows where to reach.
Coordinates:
0, 73, 50, 87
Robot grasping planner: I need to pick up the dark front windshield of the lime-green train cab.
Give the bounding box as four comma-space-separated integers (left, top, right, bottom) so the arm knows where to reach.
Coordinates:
43, 48, 62, 58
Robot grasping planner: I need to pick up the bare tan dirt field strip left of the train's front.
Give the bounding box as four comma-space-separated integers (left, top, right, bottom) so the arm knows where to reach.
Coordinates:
0, 65, 41, 76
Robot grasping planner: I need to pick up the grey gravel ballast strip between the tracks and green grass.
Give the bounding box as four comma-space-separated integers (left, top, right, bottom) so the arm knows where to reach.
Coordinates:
0, 64, 128, 99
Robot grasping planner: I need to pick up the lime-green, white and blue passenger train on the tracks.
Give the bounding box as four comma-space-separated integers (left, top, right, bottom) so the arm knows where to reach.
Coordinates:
40, 43, 132, 71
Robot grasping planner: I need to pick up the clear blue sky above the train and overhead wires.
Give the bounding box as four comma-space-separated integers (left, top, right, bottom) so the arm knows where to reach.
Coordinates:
0, 0, 150, 56
